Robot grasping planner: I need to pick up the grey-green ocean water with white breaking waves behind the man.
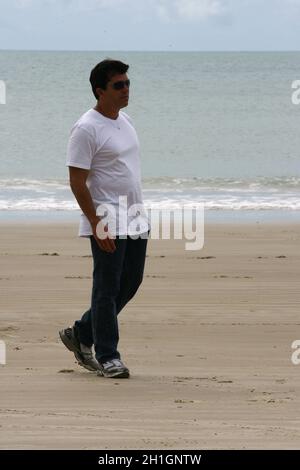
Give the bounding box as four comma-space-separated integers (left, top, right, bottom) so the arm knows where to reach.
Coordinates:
0, 51, 300, 220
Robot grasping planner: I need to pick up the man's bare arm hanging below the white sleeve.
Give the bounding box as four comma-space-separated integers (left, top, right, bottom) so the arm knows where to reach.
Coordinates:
69, 166, 116, 253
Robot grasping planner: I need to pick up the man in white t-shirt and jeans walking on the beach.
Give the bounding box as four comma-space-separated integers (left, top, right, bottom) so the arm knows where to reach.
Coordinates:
59, 59, 150, 378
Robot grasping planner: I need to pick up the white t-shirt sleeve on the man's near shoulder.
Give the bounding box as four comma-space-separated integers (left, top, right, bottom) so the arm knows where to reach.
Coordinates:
66, 127, 96, 170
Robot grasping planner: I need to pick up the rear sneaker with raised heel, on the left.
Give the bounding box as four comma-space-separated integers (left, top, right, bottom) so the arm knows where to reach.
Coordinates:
59, 326, 100, 372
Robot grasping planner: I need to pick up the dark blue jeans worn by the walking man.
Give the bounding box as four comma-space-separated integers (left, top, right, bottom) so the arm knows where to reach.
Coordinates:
75, 232, 149, 363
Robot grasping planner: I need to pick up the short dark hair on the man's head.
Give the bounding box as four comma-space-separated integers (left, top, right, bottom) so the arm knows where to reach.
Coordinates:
90, 59, 129, 100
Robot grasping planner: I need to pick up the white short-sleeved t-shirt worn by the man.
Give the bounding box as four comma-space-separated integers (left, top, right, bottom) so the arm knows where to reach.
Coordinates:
67, 109, 150, 237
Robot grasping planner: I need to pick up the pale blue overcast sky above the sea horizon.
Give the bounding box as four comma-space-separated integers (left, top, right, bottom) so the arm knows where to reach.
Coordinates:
0, 0, 300, 51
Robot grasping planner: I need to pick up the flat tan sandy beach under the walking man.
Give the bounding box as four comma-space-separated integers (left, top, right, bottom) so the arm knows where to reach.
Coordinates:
0, 223, 300, 449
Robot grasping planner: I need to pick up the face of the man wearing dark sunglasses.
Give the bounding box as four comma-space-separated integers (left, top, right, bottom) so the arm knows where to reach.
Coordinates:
97, 73, 129, 109
